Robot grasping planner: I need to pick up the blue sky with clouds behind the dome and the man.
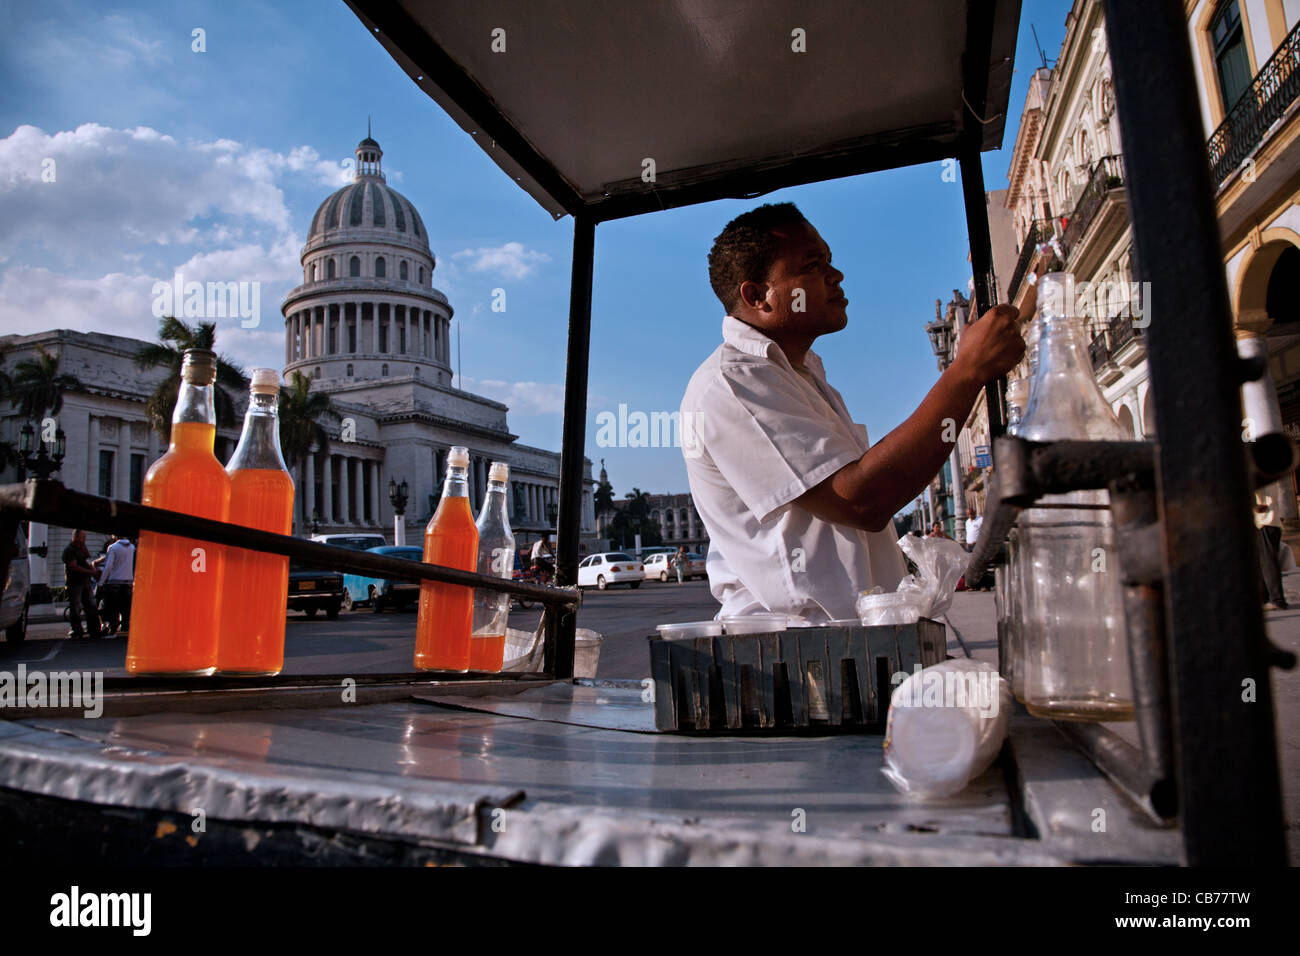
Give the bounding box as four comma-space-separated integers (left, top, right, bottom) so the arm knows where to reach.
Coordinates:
0, 0, 1070, 497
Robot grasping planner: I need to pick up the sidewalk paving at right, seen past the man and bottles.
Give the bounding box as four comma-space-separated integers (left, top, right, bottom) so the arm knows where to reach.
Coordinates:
948, 570, 1300, 866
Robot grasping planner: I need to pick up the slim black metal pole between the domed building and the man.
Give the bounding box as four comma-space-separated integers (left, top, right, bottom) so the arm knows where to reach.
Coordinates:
545, 213, 595, 678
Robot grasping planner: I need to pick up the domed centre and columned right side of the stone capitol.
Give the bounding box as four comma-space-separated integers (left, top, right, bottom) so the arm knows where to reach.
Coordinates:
282, 137, 595, 544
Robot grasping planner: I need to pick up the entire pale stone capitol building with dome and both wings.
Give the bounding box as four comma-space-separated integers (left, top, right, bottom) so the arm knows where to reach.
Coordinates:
0, 138, 595, 587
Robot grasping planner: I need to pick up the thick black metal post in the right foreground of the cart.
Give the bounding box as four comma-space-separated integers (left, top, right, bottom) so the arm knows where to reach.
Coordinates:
1104, 0, 1286, 866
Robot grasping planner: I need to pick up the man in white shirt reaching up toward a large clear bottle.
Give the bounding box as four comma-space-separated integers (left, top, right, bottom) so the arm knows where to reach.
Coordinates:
681, 203, 1034, 620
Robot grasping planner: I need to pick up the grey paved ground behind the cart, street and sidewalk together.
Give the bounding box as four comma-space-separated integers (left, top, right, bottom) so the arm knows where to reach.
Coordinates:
10, 572, 1300, 865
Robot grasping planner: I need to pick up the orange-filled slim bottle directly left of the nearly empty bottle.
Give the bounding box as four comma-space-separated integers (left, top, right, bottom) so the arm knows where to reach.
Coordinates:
415, 445, 478, 671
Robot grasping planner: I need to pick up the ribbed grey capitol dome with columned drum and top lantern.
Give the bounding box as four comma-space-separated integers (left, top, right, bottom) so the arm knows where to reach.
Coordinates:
283, 137, 452, 385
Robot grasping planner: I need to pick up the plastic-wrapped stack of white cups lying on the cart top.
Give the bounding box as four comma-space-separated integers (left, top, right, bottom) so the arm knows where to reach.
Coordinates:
883, 659, 1013, 797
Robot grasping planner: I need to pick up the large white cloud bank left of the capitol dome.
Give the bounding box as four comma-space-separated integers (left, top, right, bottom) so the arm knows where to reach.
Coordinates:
0, 124, 353, 367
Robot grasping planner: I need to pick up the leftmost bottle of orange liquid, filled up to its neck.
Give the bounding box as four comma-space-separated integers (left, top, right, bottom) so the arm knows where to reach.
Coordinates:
126, 349, 230, 676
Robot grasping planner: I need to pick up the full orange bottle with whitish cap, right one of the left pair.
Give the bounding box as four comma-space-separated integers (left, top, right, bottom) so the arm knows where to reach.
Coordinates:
217, 368, 294, 676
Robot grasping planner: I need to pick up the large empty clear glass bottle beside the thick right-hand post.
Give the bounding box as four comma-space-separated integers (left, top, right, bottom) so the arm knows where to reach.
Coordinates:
1017, 273, 1134, 721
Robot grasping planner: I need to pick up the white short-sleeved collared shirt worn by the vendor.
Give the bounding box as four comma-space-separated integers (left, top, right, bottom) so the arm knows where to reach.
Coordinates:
681, 316, 906, 622
